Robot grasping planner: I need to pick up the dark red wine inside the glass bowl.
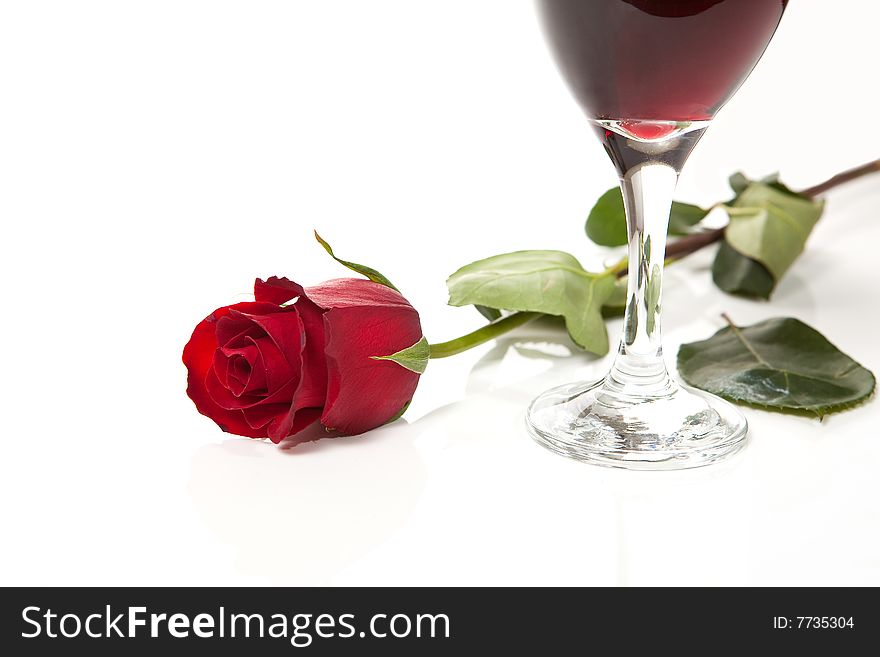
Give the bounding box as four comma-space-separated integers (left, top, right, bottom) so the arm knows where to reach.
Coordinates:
538, 0, 787, 129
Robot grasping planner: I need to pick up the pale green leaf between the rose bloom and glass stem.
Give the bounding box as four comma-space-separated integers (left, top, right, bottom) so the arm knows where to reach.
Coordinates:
446, 251, 614, 355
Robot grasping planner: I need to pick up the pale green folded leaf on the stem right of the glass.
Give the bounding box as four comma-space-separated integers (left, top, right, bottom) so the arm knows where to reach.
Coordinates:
725, 183, 825, 281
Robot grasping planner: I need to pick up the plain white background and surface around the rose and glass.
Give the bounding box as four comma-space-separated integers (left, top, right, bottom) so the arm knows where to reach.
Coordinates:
0, 0, 880, 585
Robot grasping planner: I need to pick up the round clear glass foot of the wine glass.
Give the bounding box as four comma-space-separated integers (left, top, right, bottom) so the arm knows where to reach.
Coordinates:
526, 380, 748, 470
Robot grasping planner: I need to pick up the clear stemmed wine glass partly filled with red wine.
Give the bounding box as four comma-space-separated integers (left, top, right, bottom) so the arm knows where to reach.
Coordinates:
527, 0, 787, 470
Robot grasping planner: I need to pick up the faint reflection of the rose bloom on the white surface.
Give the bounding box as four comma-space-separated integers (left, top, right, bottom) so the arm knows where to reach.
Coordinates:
189, 421, 425, 585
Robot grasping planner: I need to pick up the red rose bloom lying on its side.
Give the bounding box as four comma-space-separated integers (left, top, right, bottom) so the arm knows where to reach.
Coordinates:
183, 277, 423, 443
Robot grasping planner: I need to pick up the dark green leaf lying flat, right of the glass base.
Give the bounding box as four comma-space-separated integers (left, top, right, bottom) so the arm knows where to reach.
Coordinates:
678, 317, 875, 417
